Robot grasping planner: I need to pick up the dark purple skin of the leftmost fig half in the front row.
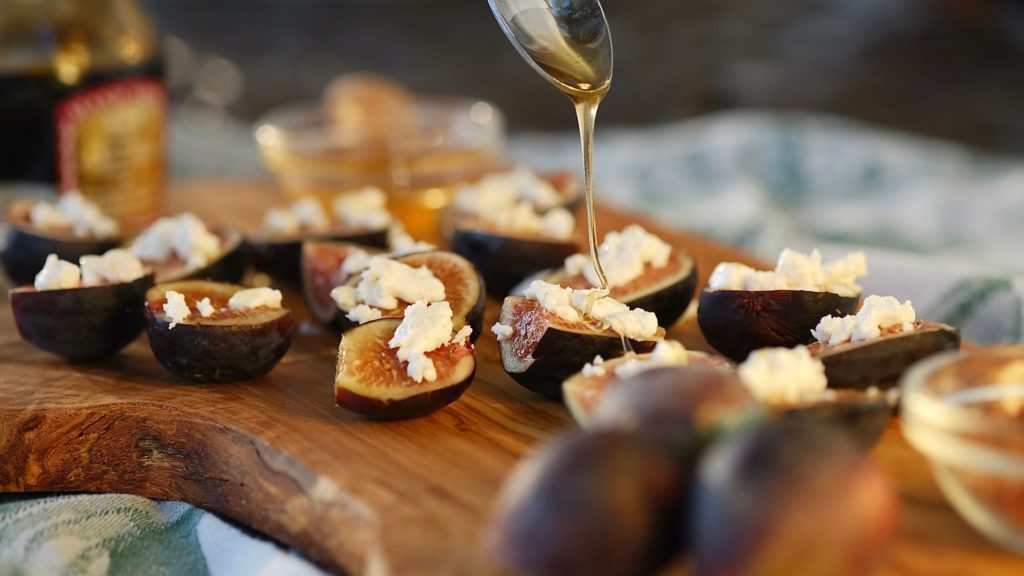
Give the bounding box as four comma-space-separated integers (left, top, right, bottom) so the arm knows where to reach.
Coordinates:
9, 274, 154, 361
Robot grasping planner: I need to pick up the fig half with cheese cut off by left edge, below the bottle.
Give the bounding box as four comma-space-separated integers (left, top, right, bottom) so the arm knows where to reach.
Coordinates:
0, 193, 122, 285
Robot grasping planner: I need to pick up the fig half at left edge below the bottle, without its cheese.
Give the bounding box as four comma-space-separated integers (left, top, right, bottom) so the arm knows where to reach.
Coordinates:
0, 201, 122, 286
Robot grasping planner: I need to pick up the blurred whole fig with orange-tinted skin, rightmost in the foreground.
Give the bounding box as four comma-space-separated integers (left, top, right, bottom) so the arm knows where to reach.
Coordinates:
684, 421, 898, 576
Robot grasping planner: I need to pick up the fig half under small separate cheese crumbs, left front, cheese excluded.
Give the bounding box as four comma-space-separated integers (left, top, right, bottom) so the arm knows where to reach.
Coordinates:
145, 280, 295, 382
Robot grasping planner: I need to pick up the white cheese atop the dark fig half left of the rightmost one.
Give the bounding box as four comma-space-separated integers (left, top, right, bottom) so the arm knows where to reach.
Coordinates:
708, 248, 867, 296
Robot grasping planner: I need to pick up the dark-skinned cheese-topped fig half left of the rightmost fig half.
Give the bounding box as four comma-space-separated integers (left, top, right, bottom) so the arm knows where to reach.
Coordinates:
697, 248, 867, 362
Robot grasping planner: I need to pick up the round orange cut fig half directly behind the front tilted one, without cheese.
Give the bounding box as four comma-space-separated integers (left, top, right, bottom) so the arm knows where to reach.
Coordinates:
329, 250, 486, 342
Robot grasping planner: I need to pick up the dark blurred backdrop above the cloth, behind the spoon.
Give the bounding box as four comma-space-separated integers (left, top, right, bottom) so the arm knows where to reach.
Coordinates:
153, 0, 1024, 155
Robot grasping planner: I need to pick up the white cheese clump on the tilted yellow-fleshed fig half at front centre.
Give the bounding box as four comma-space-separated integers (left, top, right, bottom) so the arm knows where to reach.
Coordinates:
388, 300, 472, 382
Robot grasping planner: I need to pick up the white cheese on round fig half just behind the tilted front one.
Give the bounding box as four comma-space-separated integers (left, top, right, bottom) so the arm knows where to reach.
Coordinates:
331, 256, 444, 312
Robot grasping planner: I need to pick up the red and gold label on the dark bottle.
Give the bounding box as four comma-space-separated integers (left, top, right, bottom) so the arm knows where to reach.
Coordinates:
56, 78, 167, 225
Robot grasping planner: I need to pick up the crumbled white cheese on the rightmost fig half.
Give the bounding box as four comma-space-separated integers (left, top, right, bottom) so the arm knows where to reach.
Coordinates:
811, 295, 918, 345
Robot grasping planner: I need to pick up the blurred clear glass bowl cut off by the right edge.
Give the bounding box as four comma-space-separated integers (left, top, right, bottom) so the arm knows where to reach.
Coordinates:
901, 345, 1024, 553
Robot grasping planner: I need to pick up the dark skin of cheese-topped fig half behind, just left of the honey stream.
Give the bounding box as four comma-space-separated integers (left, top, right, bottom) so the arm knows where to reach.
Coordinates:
451, 228, 580, 298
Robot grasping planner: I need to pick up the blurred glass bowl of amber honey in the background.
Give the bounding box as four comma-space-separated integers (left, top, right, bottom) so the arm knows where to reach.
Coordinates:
253, 95, 505, 241
